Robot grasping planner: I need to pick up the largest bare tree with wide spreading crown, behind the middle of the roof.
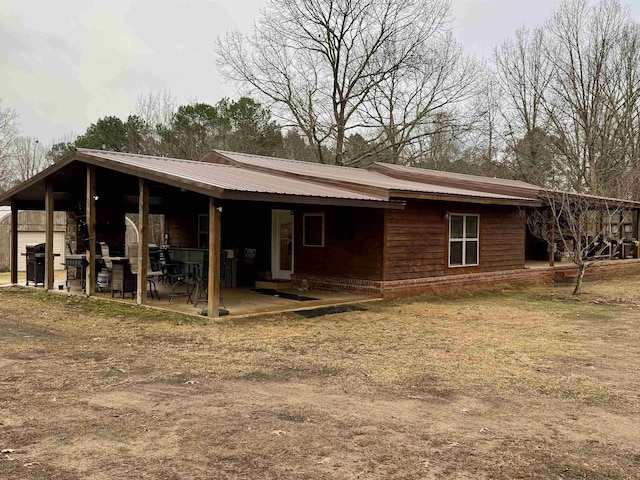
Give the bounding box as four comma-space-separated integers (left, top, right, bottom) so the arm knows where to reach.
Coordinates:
216, 0, 458, 164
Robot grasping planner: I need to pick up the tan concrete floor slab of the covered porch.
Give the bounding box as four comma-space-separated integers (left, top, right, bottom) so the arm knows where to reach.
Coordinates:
7, 272, 379, 317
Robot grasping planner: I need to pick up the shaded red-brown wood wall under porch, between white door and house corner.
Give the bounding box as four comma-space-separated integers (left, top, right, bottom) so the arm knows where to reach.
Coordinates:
294, 207, 384, 280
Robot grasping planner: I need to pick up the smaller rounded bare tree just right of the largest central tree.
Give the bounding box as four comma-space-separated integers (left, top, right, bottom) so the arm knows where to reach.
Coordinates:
361, 33, 482, 163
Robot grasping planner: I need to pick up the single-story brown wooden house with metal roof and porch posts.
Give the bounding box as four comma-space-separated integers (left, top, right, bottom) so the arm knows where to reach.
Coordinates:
0, 149, 640, 314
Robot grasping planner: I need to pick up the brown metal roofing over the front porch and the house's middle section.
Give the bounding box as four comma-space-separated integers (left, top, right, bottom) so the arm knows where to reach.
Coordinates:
0, 148, 539, 208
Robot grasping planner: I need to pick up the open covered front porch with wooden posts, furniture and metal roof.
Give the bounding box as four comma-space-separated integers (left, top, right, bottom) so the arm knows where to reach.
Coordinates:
2, 151, 397, 316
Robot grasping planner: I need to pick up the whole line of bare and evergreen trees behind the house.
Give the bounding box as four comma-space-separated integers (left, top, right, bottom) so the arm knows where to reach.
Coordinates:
0, 0, 640, 201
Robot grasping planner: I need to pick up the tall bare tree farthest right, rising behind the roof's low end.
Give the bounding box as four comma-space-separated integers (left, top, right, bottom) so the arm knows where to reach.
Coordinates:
544, 0, 640, 195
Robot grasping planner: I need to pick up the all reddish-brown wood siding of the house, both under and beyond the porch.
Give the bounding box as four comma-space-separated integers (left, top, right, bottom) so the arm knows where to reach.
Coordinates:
166, 197, 525, 284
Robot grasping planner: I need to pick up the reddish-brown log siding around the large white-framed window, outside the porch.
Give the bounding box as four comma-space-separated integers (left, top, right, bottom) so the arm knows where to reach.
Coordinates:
384, 201, 526, 280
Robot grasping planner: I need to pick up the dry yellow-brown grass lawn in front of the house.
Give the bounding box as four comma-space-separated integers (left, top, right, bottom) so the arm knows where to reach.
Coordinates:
0, 278, 640, 480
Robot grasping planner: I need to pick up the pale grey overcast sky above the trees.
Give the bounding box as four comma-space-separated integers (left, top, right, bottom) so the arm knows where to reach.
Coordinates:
0, 0, 640, 143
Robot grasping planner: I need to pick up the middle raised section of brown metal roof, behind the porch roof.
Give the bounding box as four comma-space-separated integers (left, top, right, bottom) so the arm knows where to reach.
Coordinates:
203, 150, 535, 203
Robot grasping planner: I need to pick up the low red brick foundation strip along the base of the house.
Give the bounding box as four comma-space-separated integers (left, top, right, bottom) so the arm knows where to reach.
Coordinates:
292, 259, 640, 298
